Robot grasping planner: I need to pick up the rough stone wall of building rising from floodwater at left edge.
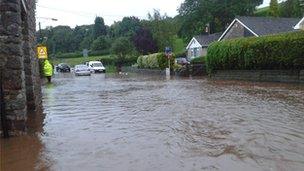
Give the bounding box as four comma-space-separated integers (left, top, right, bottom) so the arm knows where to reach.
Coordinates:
0, 0, 41, 134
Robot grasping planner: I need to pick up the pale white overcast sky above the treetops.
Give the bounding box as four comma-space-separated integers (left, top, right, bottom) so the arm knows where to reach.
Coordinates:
37, 0, 270, 28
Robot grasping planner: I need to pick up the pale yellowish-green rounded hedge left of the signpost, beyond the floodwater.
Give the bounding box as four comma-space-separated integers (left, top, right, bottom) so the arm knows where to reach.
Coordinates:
137, 53, 175, 69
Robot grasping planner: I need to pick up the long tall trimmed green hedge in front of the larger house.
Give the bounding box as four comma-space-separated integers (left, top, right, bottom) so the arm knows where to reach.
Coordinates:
206, 31, 304, 72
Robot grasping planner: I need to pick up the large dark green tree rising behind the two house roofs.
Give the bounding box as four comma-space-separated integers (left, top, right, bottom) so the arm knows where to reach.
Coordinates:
178, 0, 263, 40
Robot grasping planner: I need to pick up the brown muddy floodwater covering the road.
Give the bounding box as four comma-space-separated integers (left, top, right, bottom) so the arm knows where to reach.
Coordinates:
1, 75, 304, 171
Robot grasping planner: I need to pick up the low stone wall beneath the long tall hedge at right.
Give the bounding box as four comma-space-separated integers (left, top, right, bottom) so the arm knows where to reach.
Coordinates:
211, 70, 304, 83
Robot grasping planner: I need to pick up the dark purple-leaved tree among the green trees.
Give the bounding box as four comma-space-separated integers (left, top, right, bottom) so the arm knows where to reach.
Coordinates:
133, 28, 158, 55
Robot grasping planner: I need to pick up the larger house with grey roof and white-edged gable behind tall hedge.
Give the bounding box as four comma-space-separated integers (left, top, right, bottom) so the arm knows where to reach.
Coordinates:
218, 17, 303, 41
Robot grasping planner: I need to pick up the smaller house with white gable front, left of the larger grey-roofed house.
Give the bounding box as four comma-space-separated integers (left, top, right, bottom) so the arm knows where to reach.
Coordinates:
186, 33, 222, 59
